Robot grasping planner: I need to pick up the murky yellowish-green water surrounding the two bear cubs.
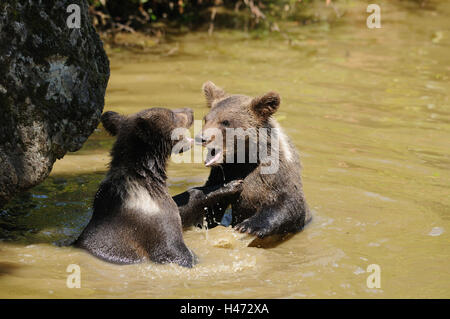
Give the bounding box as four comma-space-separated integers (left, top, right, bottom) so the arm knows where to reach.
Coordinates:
0, 1, 450, 298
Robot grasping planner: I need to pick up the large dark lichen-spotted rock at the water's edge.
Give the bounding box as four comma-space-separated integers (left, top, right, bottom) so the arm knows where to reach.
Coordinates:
0, 0, 109, 207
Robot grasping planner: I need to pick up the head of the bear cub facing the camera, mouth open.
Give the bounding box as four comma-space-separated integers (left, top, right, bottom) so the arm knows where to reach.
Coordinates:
195, 82, 280, 166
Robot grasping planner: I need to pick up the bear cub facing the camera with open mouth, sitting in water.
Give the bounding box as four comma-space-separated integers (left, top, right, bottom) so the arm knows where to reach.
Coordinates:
181, 82, 311, 238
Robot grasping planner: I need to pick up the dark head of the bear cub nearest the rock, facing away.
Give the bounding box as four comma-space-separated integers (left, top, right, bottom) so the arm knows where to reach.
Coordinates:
101, 108, 194, 160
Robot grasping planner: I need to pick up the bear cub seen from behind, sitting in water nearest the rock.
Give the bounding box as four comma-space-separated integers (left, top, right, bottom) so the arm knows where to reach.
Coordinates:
75, 108, 243, 267
